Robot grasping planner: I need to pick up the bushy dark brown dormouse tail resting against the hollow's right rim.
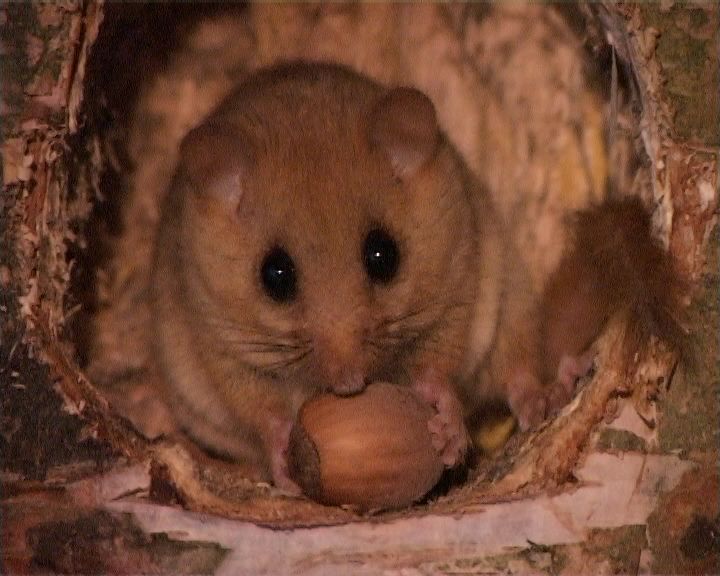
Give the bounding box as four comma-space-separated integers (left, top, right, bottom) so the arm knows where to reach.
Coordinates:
541, 197, 685, 379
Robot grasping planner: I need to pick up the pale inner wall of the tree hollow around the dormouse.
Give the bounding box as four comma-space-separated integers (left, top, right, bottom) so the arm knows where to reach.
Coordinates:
71, 4, 684, 524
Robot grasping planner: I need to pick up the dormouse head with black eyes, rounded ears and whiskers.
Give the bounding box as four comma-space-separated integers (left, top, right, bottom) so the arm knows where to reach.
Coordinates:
180, 65, 474, 394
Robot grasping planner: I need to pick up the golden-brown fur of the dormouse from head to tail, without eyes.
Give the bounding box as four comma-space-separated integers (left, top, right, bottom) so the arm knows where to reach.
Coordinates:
153, 64, 671, 487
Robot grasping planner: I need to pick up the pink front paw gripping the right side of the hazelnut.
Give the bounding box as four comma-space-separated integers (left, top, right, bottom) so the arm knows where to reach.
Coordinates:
414, 378, 469, 468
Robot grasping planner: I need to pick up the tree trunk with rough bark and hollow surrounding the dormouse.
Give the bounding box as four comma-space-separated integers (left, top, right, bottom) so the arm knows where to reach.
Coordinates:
0, 1, 720, 574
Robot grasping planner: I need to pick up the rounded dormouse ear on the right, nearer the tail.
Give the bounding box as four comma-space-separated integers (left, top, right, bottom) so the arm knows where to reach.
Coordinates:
370, 88, 440, 178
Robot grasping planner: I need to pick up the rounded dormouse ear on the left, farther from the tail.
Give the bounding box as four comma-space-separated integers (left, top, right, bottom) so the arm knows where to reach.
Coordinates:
180, 120, 254, 208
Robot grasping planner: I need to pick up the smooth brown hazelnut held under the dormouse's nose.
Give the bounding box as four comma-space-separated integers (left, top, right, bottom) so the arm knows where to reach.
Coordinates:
288, 382, 444, 510
